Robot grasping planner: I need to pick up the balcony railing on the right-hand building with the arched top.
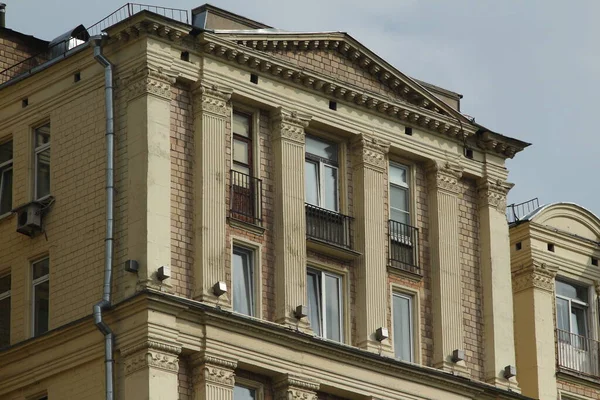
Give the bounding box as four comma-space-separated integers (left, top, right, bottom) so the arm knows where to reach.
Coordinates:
556, 329, 600, 377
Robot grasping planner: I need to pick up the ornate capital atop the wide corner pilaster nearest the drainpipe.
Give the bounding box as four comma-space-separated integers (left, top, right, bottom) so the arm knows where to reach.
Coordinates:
124, 66, 175, 101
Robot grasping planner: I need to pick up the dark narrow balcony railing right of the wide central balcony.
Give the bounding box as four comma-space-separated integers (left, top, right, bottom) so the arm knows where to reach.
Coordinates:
388, 220, 421, 274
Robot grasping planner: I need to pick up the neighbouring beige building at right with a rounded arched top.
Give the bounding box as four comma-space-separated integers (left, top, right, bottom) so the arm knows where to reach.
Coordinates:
510, 203, 600, 400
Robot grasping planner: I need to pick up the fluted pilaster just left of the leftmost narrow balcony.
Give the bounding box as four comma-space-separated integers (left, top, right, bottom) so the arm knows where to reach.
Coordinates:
193, 84, 231, 308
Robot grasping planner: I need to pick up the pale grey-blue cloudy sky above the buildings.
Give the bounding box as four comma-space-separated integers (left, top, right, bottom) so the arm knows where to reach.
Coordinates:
1, 0, 600, 216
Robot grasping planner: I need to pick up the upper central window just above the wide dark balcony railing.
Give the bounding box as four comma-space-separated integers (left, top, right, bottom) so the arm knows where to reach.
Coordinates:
304, 136, 339, 212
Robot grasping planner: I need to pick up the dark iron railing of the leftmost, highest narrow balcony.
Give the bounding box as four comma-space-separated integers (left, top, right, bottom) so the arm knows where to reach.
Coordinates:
229, 170, 262, 226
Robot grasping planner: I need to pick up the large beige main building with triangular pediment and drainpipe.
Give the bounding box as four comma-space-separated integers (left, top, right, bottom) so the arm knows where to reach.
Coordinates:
0, 6, 527, 400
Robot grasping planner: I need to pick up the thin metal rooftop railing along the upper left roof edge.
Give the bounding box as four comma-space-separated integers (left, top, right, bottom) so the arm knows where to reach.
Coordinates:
0, 3, 190, 84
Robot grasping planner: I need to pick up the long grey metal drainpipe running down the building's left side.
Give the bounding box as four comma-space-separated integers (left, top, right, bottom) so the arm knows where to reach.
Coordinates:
91, 36, 115, 400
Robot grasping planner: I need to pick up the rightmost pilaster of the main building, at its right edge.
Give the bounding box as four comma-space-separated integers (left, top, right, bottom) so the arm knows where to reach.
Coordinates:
477, 179, 517, 390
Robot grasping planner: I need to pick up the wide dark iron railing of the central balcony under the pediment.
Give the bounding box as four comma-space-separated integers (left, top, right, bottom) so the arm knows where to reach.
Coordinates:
305, 203, 354, 249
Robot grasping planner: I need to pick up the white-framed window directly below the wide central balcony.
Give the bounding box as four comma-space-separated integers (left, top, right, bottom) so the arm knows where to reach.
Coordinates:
306, 269, 344, 342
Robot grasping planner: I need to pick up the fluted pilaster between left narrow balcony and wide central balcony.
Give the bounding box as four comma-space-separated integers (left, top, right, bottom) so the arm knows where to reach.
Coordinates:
271, 108, 310, 332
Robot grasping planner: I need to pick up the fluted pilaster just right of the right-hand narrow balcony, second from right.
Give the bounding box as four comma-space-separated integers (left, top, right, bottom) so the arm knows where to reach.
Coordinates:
428, 162, 468, 374
